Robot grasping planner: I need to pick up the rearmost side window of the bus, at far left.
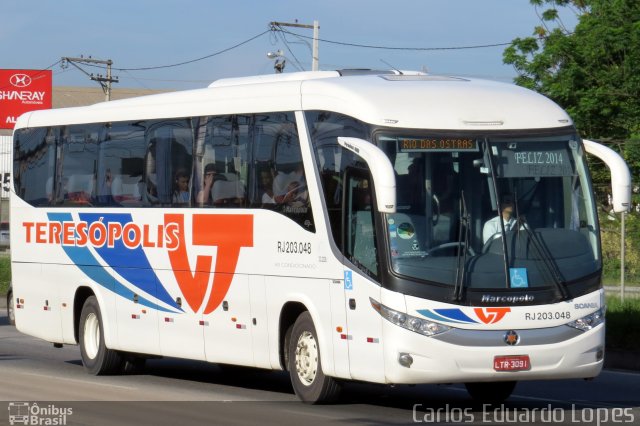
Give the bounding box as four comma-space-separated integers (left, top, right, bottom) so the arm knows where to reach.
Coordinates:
13, 128, 58, 206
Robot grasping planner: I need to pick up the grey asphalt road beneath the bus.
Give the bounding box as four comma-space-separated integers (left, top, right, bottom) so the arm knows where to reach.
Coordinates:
0, 313, 640, 426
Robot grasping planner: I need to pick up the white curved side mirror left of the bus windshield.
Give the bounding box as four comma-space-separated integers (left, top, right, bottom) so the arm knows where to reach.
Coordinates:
338, 137, 396, 213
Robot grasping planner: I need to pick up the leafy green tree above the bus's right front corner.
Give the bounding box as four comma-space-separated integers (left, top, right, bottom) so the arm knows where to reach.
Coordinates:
503, 0, 640, 140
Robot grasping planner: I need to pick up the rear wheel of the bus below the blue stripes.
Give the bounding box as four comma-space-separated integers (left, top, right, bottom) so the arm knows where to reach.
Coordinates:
79, 296, 124, 376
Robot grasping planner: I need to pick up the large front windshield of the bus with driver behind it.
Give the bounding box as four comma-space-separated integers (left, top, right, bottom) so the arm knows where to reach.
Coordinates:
377, 132, 601, 296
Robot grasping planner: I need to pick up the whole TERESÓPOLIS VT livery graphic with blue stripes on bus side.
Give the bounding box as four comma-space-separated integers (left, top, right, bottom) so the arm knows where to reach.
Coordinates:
22, 213, 253, 314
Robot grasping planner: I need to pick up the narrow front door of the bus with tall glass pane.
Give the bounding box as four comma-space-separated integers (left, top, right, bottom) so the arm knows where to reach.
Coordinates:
343, 168, 384, 381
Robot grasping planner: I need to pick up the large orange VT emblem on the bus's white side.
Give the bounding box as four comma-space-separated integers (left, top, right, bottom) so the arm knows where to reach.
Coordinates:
164, 214, 253, 314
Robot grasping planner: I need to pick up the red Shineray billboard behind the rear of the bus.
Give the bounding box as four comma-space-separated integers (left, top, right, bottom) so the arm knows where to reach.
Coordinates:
0, 70, 52, 129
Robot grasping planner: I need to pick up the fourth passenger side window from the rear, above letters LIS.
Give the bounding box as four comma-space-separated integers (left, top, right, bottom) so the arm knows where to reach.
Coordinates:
142, 119, 193, 207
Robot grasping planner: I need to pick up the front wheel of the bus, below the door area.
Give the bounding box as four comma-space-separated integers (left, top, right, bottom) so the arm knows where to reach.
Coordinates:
287, 312, 340, 404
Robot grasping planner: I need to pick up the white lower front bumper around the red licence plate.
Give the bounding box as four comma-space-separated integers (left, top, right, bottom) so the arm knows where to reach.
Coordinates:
384, 323, 605, 384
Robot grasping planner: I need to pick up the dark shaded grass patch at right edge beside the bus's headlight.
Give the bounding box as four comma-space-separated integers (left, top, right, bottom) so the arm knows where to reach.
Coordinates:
606, 296, 640, 351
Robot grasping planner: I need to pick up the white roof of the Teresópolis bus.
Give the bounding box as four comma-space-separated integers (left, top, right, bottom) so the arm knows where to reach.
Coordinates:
16, 70, 572, 131
